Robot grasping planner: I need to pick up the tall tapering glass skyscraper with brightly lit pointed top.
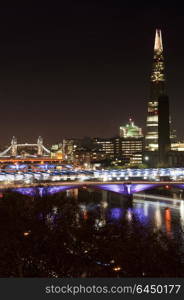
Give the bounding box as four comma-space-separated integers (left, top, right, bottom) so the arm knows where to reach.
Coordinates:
145, 29, 166, 151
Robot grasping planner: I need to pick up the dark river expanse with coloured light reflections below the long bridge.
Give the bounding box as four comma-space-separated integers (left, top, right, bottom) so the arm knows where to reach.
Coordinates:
0, 189, 184, 277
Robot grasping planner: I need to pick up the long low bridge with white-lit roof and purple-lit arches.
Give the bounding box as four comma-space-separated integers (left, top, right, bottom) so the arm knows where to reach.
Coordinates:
0, 165, 184, 195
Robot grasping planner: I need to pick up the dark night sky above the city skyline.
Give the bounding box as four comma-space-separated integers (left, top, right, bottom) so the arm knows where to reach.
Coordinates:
0, 0, 184, 145
